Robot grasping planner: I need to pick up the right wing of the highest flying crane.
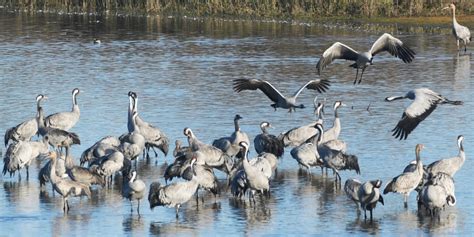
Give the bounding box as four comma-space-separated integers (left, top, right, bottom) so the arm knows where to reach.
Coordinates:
370, 33, 416, 63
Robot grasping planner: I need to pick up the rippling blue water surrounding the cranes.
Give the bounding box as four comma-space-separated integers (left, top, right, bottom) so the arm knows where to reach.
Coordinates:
0, 11, 474, 235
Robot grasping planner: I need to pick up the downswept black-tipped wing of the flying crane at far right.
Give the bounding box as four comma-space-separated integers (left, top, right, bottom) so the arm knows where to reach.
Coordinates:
392, 90, 439, 140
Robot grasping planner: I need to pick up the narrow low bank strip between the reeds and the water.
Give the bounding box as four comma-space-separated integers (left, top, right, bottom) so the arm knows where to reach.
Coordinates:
0, 5, 474, 33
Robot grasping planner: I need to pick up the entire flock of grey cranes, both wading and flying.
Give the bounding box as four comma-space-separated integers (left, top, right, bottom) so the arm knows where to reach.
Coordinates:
3, 4, 471, 224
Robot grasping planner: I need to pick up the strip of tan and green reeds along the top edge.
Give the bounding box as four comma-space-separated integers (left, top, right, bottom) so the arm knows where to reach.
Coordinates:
0, 0, 474, 20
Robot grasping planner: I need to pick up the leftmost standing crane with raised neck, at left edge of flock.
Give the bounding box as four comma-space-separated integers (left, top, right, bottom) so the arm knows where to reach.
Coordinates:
4, 94, 47, 147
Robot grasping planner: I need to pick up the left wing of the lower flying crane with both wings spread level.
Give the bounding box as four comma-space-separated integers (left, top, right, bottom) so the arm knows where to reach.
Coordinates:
234, 79, 285, 103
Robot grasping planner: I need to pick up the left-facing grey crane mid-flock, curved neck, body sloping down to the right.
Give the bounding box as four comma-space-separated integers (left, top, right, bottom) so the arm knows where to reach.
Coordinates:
184, 128, 233, 174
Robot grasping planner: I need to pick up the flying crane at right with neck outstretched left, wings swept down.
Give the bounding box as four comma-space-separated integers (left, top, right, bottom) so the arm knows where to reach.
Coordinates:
385, 88, 463, 140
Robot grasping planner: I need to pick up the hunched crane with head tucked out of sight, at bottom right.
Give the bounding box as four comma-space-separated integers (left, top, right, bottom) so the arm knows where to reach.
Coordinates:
419, 172, 456, 217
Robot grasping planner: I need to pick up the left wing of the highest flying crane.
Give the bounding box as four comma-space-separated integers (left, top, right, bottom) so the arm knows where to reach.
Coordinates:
316, 42, 359, 75
